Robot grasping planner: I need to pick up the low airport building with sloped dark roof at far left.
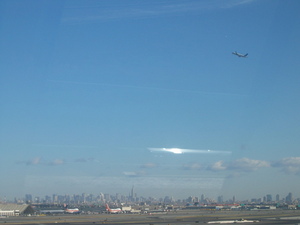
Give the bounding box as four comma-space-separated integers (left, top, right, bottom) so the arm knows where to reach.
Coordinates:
0, 203, 34, 217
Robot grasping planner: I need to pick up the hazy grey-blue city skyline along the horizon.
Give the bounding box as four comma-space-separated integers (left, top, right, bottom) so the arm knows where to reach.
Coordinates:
0, 188, 300, 204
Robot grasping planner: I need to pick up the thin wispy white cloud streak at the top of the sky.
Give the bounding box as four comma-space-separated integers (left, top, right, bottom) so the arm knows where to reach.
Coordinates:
63, 0, 254, 23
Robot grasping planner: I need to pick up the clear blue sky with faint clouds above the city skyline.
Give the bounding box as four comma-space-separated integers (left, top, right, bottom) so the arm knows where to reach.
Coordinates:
0, 0, 300, 199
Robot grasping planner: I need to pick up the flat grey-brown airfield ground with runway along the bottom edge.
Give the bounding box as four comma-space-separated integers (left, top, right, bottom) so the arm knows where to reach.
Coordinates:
0, 210, 300, 225
